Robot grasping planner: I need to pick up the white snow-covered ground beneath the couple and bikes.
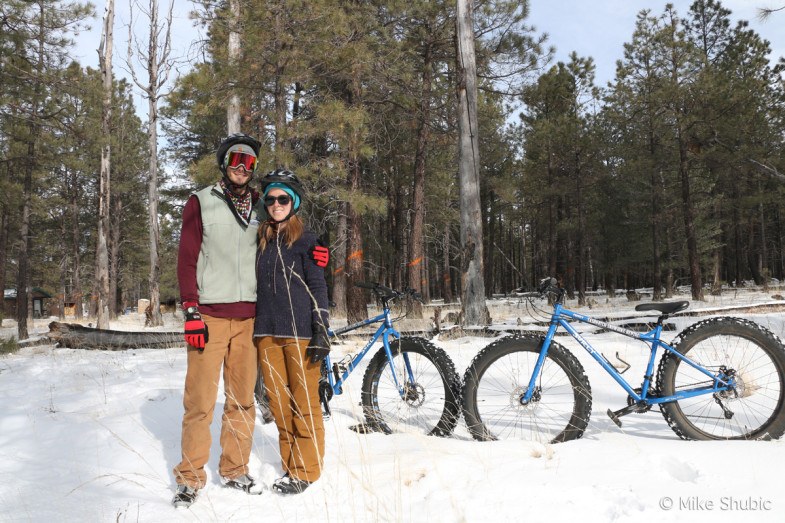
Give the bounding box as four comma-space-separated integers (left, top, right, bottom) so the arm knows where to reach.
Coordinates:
0, 292, 785, 522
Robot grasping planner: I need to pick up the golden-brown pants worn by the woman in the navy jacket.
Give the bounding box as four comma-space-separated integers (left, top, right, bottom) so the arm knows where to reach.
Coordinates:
255, 337, 324, 481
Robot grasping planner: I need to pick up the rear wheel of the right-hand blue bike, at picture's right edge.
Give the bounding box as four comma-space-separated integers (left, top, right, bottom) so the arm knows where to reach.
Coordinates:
657, 317, 785, 440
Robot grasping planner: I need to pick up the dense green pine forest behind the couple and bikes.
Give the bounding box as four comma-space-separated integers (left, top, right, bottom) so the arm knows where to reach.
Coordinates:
0, 0, 785, 340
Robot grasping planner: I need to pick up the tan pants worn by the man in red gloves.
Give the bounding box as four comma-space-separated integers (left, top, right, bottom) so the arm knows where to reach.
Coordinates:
174, 315, 258, 488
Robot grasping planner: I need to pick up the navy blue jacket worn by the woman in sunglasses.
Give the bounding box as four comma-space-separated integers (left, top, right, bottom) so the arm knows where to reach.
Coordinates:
254, 231, 329, 339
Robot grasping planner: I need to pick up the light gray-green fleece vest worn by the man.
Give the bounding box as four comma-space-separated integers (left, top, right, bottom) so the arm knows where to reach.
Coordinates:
196, 184, 259, 304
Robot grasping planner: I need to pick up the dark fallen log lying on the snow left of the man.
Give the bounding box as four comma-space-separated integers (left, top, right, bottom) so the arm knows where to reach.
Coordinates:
46, 321, 185, 350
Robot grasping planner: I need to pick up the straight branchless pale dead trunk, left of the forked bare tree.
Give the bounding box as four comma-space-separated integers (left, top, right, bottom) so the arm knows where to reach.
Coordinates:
95, 0, 114, 329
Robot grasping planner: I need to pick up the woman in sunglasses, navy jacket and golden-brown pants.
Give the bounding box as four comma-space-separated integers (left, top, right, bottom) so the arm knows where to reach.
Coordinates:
254, 169, 330, 494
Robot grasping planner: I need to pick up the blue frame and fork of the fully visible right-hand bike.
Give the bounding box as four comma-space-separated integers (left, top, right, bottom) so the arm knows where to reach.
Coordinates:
521, 303, 736, 405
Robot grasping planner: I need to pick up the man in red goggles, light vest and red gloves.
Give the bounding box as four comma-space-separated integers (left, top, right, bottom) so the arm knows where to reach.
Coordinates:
172, 134, 329, 507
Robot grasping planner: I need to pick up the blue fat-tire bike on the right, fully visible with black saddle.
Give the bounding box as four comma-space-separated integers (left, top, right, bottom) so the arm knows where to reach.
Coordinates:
463, 278, 785, 443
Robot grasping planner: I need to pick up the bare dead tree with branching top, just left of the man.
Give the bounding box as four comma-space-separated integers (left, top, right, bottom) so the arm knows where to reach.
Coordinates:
126, 0, 175, 326
